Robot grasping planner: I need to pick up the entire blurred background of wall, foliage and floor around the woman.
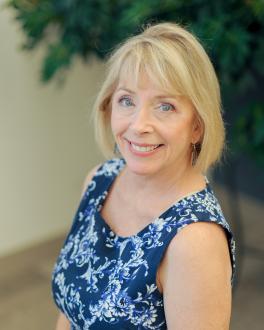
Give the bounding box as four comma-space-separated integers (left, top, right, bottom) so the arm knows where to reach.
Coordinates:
0, 0, 264, 330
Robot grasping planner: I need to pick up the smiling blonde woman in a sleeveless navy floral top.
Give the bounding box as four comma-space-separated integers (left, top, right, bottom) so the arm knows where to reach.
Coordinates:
52, 23, 235, 330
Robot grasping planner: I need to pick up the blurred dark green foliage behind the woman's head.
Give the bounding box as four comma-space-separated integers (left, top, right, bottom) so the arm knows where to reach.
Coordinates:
6, 0, 264, 165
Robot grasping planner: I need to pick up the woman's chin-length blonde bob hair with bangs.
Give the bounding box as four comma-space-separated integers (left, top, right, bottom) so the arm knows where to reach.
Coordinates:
92, 22, 225, 172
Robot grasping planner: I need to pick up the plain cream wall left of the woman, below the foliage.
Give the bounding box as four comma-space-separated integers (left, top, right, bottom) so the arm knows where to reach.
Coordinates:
0, 6, 104, 256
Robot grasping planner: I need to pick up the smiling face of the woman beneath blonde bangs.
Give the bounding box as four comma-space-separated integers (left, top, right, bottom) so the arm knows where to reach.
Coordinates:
111, 76, 200, 175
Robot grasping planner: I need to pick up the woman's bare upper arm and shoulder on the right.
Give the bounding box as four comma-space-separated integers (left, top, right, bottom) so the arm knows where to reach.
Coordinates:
161, 221, 232, 330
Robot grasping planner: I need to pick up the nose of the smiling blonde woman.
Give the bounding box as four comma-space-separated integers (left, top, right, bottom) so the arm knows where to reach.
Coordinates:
130, 107, 153, 134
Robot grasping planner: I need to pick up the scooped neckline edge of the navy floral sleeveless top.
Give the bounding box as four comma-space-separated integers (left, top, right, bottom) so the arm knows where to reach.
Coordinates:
95, 158, 210, 241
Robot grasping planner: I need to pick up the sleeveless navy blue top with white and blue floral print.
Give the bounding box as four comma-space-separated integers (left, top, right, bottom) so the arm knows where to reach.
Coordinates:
52, 158, 235, 330
